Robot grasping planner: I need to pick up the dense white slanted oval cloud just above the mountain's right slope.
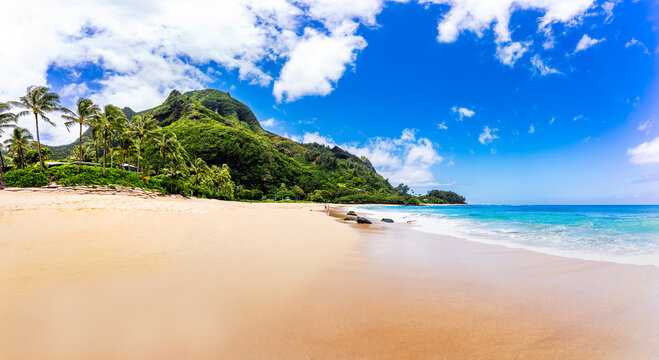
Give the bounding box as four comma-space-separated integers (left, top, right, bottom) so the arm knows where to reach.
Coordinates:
273, 22, 366, 101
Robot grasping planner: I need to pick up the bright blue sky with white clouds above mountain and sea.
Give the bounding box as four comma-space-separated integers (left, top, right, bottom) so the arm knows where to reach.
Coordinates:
0, 0, 659, 204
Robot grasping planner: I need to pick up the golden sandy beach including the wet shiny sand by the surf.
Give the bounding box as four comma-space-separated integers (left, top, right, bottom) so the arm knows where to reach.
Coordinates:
0, 192, 659, 359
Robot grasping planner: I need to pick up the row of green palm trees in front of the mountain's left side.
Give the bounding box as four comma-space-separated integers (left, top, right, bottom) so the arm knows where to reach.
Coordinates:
0, 86, 235, 199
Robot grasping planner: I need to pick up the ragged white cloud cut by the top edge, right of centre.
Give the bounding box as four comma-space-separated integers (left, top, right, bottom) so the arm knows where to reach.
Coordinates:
420, 0, 595, 66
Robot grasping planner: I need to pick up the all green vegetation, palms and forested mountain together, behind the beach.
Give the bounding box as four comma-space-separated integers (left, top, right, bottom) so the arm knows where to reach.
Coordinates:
0, 86, 465, 205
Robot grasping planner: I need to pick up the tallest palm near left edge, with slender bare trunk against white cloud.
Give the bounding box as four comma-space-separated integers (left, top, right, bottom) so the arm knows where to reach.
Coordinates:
9, 85, 62, 171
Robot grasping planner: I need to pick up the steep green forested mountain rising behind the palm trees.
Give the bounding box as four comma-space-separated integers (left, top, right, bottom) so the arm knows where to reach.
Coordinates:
50, 89, 395, 201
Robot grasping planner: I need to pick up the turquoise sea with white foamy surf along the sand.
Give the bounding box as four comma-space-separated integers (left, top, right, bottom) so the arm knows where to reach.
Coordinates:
359, 205, 659, 266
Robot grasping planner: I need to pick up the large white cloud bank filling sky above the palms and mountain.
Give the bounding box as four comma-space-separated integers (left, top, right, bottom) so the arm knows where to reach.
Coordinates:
0, 0, 384, 140
